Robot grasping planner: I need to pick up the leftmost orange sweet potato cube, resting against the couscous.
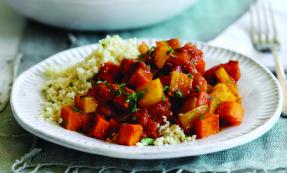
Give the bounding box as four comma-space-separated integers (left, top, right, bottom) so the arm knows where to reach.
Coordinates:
61, 106, 83, 131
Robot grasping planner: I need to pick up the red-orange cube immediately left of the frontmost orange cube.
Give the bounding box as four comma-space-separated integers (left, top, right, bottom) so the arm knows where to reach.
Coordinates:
89, 115, 110, 139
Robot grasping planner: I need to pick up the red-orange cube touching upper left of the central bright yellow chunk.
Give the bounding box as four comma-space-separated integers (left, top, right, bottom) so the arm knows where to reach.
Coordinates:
129, 68, 153, 88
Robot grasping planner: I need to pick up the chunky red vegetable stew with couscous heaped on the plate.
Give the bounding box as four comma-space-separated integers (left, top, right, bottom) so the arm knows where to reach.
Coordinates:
42, 36, 244, 146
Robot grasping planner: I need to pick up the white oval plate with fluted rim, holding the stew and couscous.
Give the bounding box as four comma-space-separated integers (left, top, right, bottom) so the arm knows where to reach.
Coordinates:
11, 41, 282, 159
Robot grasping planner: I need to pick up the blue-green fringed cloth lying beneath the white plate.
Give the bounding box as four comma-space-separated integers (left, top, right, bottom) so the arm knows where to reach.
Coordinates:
5, 0, 287, 172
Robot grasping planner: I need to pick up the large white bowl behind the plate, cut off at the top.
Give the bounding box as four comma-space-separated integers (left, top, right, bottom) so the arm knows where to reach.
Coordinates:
6, 0, 198, 30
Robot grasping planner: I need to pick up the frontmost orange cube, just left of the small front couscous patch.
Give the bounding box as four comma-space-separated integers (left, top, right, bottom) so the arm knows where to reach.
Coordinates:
118, 124, 143, 146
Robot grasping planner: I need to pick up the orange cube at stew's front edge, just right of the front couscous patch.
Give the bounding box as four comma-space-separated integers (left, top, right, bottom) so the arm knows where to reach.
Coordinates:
195, 113, 219, 138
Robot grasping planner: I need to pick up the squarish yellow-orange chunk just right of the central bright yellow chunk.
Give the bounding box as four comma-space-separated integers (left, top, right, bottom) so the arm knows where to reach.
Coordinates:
170, 71, 192, 96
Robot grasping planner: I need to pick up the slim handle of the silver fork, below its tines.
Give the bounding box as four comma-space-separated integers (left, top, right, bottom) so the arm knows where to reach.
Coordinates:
272, 47, 287, 117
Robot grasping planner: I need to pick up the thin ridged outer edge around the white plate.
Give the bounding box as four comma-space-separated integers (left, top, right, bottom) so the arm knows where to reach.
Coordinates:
10, 39, 282, 159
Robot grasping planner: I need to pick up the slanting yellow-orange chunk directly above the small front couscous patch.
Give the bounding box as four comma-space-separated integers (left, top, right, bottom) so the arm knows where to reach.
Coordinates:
179, 105, 208, 132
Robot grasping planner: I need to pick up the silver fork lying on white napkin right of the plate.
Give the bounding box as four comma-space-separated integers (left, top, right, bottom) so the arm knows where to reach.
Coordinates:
250, 1, 287, 117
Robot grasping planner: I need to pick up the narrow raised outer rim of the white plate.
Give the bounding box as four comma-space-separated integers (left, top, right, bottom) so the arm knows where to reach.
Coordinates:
10, 39, 282, 159
